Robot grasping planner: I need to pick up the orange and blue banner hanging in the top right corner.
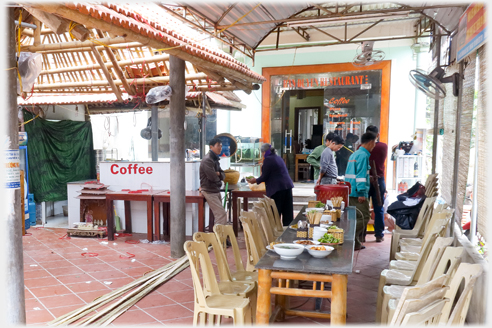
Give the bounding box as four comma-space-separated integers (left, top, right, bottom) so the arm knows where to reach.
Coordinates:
456, 3, 487, 62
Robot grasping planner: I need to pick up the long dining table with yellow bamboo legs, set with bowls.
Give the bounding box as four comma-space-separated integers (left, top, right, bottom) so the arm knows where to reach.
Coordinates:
255, 207, 356, 325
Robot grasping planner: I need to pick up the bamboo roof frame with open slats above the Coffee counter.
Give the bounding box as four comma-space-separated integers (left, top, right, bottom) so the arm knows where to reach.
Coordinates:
18, 3, 264, 109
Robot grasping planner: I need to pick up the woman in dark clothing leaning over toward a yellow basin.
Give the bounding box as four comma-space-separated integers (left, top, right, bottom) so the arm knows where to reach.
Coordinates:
248, 144, 294, 226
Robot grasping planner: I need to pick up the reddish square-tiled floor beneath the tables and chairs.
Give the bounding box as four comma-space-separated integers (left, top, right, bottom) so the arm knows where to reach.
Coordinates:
23, 226, 391, 325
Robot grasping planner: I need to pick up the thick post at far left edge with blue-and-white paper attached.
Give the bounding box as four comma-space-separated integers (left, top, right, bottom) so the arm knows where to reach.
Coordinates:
0, 7, 26, 327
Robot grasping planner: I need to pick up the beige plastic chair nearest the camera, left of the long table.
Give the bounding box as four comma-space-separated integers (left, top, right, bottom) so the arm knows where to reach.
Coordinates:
184, 241, 252, 326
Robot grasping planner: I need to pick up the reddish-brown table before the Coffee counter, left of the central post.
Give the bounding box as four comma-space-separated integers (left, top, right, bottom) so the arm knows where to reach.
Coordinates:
106, 190, 158, 241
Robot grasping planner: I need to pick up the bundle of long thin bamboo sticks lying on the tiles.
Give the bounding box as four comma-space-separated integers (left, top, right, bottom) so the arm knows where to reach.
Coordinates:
48, 256, 190, 326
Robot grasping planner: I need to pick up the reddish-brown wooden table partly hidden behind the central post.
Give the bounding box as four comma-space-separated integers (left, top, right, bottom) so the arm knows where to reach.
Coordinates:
154, 190, 206, 240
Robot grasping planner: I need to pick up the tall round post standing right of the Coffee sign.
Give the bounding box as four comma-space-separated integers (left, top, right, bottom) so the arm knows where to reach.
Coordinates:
169, 56, 186, 258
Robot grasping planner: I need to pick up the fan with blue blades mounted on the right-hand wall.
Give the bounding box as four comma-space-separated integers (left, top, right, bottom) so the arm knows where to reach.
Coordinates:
408, 67, 460, 99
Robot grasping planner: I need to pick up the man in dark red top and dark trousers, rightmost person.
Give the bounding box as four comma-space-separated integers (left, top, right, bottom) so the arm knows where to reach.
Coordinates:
364, 125, 388, 243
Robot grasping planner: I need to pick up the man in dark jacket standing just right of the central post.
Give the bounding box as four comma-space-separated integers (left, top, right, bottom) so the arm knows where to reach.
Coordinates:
200, 138, 227, 224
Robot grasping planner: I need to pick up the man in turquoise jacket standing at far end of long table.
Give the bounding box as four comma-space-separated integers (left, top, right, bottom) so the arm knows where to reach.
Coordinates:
345, 132, 376, 250
